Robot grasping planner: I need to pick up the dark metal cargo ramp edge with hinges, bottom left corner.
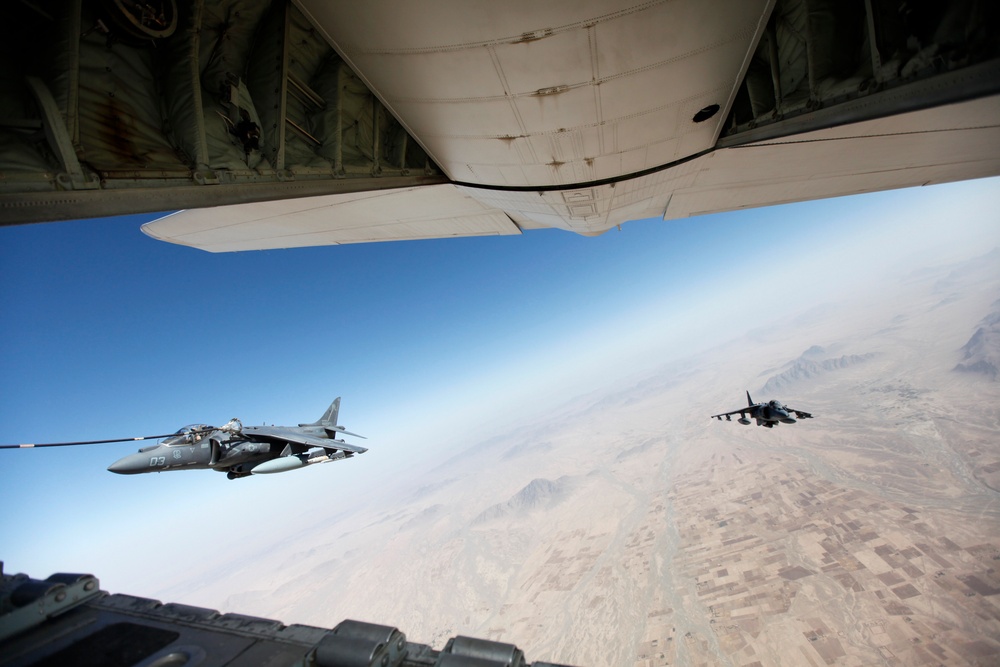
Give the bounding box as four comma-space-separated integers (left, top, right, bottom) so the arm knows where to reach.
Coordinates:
0, 563, 576, 667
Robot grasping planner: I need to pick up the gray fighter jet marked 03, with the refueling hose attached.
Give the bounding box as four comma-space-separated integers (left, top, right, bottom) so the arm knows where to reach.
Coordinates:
0, 396, 368, 479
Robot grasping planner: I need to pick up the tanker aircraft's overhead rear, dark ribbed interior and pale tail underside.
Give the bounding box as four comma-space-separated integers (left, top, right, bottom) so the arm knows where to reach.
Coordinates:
0, 0, 1000, 252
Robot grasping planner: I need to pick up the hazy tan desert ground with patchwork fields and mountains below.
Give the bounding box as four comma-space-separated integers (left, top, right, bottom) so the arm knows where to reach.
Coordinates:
168, 251, 1000, 667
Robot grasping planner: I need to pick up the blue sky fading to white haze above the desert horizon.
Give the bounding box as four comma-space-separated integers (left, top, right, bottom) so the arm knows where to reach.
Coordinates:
0, 179, 1000, 594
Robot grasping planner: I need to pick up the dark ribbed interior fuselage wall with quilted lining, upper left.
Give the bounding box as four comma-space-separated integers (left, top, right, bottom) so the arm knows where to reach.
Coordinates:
0, 0, 446, 223
